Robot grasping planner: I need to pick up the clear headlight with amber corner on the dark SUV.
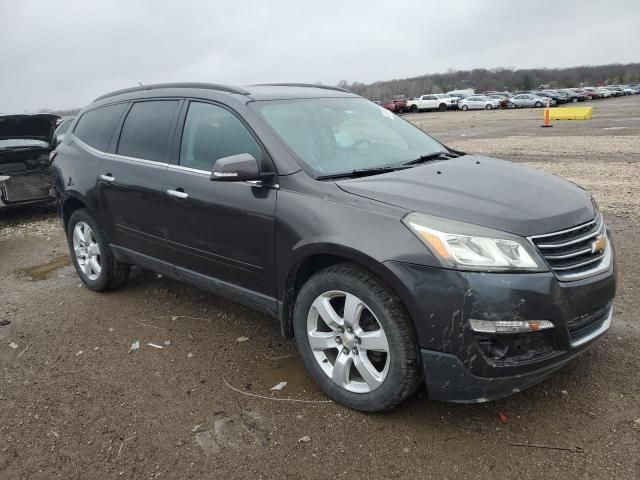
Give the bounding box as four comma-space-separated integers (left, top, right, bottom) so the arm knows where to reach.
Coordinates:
402, 212, 547, 272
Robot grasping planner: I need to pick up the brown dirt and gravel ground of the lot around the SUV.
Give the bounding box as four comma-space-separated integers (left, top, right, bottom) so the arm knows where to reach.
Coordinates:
0, 96, 640, 480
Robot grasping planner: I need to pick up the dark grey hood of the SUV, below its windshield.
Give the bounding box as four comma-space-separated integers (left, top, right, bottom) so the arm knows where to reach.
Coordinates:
336, 155, 595, 236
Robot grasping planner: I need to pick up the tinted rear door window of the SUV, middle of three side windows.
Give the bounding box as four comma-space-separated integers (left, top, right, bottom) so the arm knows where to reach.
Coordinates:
117, 100, 178, 162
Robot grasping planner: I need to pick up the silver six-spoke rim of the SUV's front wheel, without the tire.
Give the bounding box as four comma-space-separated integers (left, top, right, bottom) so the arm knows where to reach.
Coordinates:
307, 290, 390, 393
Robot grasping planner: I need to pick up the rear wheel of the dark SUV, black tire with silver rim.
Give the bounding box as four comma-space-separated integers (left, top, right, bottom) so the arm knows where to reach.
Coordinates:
67, 209, 129, 292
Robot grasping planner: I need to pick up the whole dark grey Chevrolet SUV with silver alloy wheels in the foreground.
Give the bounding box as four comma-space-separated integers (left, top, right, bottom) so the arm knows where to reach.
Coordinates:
52, 84, 616, 411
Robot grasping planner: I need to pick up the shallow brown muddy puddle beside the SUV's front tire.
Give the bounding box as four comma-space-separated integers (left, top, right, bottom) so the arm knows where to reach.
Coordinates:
247, 355, 322, 398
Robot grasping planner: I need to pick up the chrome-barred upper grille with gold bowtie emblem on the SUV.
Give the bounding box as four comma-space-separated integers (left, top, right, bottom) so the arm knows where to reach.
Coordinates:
530, 215, 609, 280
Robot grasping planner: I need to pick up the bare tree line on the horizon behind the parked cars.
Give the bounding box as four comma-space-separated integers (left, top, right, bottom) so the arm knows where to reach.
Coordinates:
338, 63, 640, 101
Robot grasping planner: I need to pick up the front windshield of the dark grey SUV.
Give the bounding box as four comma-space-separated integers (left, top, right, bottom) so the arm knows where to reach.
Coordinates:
250, 98, 447, 177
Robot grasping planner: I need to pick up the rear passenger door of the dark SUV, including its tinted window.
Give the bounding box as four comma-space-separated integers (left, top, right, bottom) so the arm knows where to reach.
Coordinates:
98, 99, 181, 261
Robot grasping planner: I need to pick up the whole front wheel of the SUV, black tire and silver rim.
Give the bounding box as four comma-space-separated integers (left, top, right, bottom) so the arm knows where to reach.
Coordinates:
294, 263, 422, 412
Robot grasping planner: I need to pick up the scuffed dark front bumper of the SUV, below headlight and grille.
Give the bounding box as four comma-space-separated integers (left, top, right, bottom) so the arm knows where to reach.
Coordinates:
385, 251, 616, 402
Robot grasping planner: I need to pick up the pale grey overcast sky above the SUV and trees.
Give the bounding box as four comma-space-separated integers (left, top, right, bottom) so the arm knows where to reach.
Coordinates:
0, 0, 640, 112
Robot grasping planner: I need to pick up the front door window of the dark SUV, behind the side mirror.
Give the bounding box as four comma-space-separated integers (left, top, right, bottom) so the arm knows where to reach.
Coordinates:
180, 102, 262, 171
